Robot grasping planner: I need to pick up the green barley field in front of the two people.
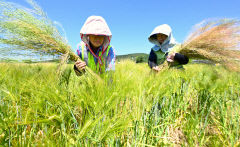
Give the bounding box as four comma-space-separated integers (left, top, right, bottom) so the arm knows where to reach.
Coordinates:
0, 60, 240, 146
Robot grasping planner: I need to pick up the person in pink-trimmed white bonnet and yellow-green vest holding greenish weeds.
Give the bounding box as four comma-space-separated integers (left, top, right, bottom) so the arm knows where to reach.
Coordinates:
74, 16, 116, 75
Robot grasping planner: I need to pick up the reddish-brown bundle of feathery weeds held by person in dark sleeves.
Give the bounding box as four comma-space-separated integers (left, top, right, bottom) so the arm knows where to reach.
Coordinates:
179, 19, 240, 71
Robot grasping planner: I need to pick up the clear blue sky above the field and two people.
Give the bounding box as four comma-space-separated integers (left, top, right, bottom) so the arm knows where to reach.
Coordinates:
4, 0, 240, 55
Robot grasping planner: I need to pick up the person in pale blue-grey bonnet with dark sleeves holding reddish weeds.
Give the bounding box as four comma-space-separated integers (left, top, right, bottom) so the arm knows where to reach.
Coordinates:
148, 24, 189, 72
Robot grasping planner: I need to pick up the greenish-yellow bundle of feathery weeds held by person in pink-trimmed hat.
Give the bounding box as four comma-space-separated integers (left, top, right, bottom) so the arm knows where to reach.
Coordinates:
0, 0, 96, 76
